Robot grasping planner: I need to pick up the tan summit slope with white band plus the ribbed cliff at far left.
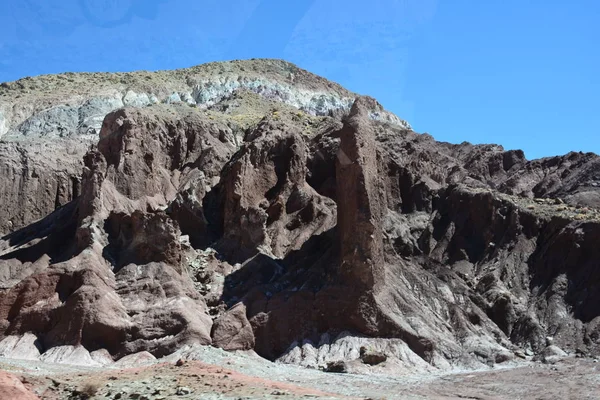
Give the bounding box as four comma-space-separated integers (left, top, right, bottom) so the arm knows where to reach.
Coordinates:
0, 60, 408, 234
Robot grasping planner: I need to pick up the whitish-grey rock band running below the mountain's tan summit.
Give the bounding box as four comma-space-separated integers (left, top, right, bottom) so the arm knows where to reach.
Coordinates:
0, 75, 410, 140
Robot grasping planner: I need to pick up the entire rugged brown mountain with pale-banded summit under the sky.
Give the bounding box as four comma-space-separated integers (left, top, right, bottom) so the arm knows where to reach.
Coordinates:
0, 60, 600, 371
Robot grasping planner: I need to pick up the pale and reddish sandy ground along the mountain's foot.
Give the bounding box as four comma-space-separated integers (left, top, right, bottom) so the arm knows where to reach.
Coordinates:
0, 348, 600, 400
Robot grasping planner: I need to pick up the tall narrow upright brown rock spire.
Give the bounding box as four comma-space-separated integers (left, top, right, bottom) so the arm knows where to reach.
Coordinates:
336, 97, 386, 289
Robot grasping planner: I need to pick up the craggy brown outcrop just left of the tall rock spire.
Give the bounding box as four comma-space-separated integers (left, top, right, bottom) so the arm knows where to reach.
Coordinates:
219, 120, 336, 261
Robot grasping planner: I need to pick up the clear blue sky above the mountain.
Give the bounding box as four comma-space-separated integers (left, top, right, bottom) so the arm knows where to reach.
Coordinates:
0, 0, 600, 158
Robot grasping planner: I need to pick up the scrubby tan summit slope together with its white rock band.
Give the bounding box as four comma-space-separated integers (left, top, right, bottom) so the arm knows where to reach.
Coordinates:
0, 60, 408, 141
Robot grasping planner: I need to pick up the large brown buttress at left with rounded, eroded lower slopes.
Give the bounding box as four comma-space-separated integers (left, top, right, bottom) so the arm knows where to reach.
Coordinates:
0, 103, 239, 357
